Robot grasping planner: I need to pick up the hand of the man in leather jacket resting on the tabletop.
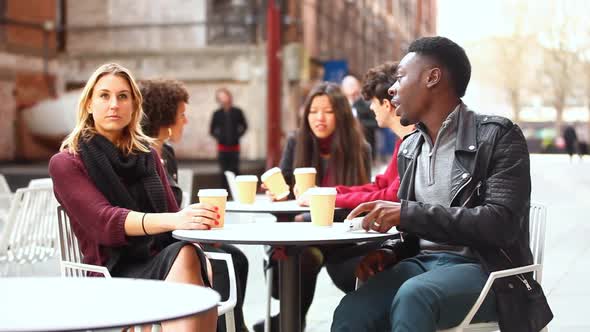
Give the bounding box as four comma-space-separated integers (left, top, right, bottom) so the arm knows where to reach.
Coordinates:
346, 201, 401, 233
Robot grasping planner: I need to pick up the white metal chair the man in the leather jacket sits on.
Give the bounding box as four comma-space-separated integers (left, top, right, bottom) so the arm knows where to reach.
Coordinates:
356, 202, 547, 332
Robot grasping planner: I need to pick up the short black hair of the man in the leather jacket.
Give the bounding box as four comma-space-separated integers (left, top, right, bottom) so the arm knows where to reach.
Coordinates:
408, 36, 471, 98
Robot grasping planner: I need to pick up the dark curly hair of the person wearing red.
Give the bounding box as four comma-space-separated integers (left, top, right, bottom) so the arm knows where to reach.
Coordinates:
361, 62, 397, 103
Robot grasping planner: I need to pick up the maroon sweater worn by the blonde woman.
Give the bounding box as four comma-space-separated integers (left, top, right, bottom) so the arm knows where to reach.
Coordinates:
49, 150, 178, 265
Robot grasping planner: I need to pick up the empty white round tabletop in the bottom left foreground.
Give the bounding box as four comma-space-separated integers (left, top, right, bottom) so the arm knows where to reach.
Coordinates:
0, 277, 220, 331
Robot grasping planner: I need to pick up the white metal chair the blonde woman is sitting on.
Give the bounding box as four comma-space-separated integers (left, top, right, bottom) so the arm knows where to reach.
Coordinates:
57, 206, 237, 332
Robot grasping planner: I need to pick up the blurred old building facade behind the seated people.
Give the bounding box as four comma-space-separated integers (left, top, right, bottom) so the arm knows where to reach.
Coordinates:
0, 0, 436, 160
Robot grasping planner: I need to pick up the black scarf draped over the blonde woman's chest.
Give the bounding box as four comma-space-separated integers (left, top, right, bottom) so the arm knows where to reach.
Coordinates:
80, 134, 173, 271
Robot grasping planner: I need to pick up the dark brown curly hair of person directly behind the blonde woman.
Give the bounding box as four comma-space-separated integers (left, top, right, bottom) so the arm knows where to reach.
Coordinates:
139, 80, 189, 137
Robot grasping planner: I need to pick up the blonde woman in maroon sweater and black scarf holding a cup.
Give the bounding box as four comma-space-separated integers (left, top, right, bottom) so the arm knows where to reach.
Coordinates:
49, 64, 219, 331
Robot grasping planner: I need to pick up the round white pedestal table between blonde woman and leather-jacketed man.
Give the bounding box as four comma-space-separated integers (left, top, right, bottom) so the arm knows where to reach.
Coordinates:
172, 219, 396, 332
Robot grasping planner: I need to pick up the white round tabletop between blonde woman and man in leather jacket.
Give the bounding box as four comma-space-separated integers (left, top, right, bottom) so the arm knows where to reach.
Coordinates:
172, 222, 397, 245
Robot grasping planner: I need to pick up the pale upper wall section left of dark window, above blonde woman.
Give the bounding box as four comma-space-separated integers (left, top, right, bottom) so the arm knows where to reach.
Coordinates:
66, 0, 206, 55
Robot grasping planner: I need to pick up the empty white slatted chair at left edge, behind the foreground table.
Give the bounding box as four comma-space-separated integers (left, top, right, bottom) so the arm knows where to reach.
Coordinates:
0, 188, 57, 274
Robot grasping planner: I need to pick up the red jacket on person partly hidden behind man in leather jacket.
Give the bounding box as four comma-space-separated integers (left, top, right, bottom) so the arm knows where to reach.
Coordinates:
336, 139, 402, 209
